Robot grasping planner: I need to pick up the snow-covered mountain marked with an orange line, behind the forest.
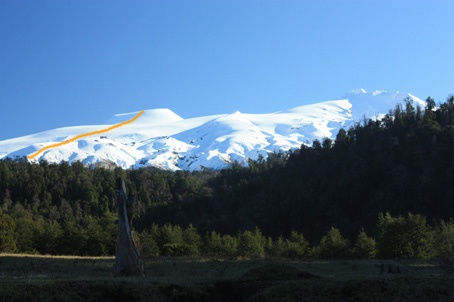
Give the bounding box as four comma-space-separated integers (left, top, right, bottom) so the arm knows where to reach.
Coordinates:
0, 89, 425, 170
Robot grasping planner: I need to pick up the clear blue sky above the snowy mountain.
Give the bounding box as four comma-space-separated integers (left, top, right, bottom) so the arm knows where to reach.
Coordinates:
0, 0, 454, 140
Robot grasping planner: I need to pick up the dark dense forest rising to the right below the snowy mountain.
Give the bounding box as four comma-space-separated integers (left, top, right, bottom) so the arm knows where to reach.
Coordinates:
0, 97, 454, 258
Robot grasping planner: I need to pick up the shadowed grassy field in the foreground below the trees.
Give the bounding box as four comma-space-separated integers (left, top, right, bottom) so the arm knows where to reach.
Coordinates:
0, 254, 454, 302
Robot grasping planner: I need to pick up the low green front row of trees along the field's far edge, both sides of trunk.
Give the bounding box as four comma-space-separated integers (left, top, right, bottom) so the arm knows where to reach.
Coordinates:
0, 204, 454, 265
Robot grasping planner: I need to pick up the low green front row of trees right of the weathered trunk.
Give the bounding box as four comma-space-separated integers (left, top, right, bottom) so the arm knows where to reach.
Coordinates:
137, 213, 454, 262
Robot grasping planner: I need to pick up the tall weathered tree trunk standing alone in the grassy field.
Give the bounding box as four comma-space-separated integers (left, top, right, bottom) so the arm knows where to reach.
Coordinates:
114, 179, 145, 277
